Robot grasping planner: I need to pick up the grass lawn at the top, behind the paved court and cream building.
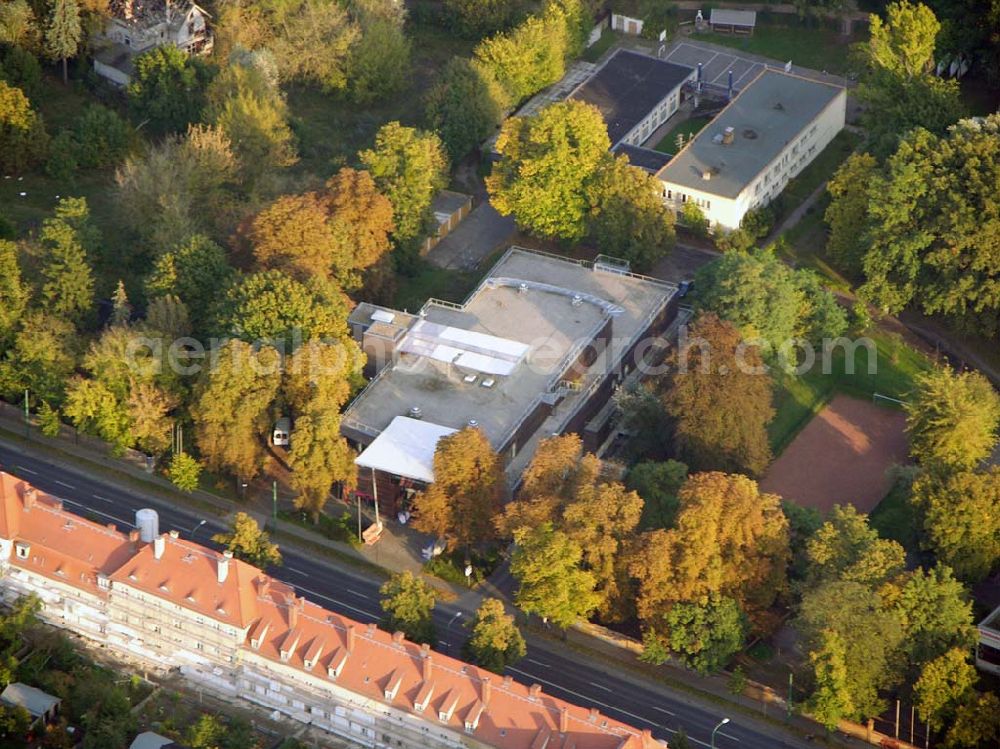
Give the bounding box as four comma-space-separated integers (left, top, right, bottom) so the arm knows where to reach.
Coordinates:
691, 26, 860, 75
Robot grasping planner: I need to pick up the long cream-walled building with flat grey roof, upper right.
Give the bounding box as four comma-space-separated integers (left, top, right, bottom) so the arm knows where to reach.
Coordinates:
657, 70, 847, 229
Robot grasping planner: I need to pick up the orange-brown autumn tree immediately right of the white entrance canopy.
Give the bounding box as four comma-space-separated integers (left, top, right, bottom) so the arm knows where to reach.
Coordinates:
413, 427, 506, 550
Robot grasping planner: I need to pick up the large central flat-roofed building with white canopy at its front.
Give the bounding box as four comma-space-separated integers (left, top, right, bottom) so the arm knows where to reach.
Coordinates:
341, 248, 676, 499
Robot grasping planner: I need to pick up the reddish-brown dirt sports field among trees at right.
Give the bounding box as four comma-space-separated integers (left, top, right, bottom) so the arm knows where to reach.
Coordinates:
761, 395, 907, 513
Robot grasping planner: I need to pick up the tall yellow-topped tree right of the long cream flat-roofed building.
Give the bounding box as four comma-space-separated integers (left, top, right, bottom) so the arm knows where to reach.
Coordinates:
858, 0, 962, 155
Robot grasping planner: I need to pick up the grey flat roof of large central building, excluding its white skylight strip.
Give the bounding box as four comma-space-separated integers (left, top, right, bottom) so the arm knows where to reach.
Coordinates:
342, 248, 676, 447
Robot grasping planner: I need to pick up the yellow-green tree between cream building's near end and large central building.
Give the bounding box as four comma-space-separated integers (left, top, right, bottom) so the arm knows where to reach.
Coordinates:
588, 155, 675, 271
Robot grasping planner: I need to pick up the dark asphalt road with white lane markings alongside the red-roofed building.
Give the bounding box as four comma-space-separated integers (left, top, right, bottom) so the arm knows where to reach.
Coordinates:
0, 443, 815, 749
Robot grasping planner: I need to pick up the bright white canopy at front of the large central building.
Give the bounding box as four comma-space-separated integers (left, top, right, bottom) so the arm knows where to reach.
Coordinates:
354, 416, 458, 484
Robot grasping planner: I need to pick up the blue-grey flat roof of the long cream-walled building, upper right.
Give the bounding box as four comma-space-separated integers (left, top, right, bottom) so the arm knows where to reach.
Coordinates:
657, 70, 845, 198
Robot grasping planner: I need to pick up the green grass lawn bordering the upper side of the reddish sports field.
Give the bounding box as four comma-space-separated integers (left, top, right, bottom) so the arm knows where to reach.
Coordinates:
768, 330, 932, 455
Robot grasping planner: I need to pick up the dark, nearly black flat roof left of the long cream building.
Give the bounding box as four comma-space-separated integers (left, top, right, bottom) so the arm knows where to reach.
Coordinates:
571, 49, 694, 146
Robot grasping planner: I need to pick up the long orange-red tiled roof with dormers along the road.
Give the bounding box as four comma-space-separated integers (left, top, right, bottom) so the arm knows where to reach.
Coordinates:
0, 472, 663, 749
